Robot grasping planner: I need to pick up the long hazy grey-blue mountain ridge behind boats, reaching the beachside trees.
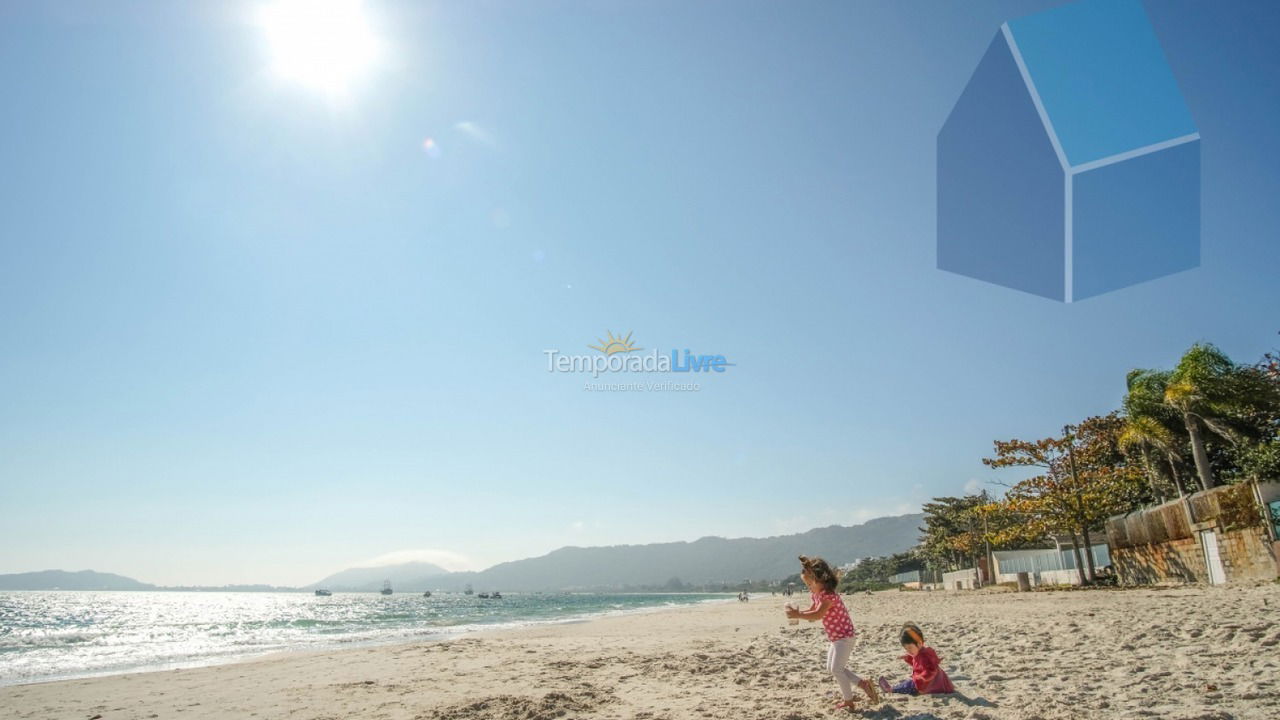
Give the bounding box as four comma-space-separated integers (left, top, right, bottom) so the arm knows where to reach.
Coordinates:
311, 512, 924, 592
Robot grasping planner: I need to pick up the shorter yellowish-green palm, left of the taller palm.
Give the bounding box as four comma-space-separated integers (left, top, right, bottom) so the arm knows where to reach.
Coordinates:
1119, 370, 1187, 500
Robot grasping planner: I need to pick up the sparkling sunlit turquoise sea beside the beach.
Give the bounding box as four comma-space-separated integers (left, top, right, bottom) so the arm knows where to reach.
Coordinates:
0, 591, 724, 685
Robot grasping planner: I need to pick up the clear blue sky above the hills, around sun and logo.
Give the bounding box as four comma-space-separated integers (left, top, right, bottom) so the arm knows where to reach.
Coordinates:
0, 0, 1280, 584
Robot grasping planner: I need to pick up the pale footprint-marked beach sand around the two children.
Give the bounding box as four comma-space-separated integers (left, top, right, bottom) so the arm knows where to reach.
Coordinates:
0, 583, 1280, 720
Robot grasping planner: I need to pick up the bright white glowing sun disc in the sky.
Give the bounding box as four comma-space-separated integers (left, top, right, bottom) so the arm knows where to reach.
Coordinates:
257, 0, 381, 96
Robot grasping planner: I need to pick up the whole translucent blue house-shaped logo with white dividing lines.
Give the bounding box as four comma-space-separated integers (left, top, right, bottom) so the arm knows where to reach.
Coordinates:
937, 0, 1199, 302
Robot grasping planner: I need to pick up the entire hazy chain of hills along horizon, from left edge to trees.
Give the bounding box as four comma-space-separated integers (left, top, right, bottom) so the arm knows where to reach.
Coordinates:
0, 514, 924, 592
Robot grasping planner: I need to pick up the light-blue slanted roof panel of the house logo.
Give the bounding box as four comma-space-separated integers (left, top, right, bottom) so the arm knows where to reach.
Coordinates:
1005, 0, 1197, 167
